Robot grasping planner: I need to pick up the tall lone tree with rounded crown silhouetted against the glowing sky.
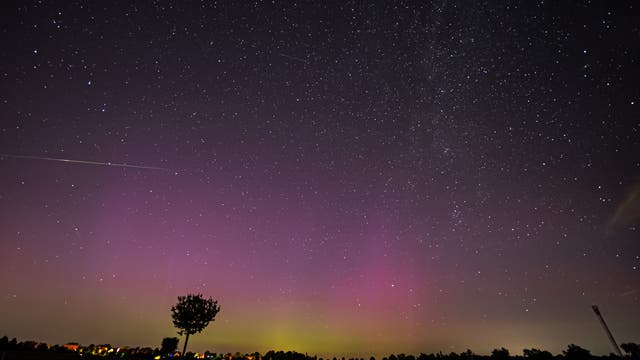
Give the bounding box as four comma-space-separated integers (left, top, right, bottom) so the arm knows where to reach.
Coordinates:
171, 294, 220, 356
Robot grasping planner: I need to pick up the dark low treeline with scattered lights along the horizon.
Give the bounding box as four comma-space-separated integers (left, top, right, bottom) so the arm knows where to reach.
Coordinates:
0, 336, 640, 360
